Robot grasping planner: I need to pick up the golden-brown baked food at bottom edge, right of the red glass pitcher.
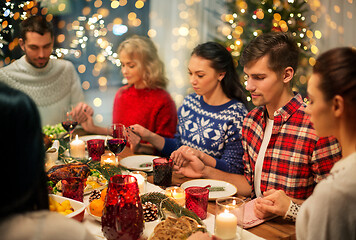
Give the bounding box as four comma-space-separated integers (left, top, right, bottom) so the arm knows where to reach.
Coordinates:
150, 216, 205, 240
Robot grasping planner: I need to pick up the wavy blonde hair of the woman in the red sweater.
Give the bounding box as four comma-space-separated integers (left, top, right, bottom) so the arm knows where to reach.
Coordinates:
117, 35, 167, 89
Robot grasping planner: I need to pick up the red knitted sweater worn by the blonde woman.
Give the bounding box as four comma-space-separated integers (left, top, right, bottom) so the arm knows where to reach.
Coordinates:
113, 86, 177, 138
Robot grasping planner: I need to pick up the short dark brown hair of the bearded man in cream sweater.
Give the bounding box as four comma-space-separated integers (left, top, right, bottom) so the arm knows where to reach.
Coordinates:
20, 15, 53, 41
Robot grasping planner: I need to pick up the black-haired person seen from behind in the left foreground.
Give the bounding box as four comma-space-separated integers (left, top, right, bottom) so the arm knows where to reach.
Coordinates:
0, 83, 94, 240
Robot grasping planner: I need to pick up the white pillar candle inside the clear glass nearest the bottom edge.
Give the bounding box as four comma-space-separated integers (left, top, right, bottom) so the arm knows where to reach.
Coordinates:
215, 212, 237, 239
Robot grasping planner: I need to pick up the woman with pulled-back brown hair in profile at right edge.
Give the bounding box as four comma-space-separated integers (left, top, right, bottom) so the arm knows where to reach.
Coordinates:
256, 47, 356, 239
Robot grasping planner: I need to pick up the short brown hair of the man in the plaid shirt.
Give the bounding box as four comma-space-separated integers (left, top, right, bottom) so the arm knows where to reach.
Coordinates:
240, 32, 299, 73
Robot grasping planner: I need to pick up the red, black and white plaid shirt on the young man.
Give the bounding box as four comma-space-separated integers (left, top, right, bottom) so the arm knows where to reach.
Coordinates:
242, 94, 341, 199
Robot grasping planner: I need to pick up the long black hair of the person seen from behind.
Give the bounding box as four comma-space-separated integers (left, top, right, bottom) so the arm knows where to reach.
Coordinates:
0, 83, 48, 219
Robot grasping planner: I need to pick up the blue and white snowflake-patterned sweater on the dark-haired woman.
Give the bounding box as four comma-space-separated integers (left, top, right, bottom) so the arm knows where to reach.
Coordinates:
162, 93, 247, 174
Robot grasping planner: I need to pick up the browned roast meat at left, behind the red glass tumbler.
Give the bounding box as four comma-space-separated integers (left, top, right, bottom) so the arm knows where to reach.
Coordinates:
47, 163, 90, 184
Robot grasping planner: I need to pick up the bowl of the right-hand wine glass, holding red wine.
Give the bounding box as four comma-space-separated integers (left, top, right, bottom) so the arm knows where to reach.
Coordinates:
107, 123, 127, 156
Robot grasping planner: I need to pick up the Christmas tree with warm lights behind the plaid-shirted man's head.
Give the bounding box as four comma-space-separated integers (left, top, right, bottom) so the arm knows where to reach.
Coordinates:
221, 0, 317, 100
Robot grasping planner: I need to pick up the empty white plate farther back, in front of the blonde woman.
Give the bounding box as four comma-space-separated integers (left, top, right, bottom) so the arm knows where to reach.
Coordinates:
120, 155, 159, 172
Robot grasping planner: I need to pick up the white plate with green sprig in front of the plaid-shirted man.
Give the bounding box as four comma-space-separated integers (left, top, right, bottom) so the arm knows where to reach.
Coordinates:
181, 179, 237, 200
